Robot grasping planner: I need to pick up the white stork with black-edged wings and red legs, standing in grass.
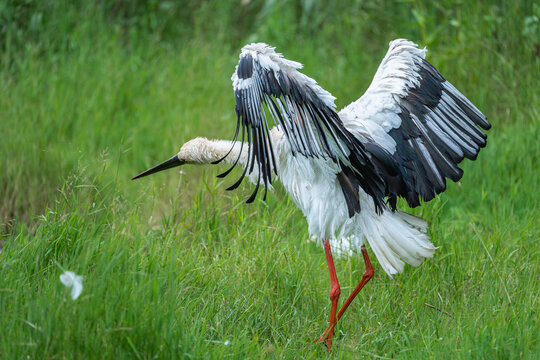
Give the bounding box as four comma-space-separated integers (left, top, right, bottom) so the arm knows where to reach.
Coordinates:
134, 39, 490, 348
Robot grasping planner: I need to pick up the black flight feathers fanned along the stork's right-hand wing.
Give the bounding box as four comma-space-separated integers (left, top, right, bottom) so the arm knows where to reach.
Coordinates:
374, 59, 490, 210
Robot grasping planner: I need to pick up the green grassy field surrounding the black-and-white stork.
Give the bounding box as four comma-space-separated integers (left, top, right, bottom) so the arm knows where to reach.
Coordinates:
0, 0, 540, 359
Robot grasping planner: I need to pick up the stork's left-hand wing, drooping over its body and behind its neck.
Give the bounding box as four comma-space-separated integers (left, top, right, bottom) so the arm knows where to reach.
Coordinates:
220, 44, 385, 212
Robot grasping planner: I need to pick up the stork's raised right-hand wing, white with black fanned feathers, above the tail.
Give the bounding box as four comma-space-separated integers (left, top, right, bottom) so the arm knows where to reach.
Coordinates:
340, 39, 491, 209
